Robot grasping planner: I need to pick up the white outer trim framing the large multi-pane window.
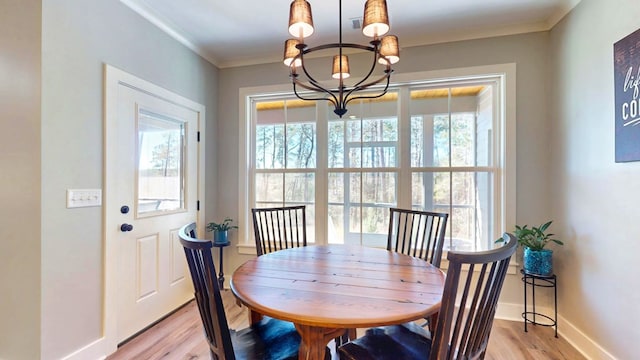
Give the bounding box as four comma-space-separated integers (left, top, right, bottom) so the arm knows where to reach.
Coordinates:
237, 63, 516, 258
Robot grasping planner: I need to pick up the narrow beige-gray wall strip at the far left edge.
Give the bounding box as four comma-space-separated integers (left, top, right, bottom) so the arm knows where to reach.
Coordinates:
0, 0, 41, 359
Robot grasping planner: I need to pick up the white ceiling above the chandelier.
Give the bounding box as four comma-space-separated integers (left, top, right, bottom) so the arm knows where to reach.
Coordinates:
120, 0, 580, 68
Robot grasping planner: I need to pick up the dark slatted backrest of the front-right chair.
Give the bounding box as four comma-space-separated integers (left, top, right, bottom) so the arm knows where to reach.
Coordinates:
429, 233, 518, 360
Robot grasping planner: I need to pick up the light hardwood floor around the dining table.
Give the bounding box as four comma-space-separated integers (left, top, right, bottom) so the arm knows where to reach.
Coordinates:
107, 290, 585, 360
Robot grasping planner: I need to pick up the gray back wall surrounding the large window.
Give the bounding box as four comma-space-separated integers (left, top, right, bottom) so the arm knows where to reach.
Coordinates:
216, 32, 550, 310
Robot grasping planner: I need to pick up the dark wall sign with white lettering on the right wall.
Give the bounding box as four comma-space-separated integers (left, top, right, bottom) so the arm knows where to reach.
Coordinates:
613, 29, 640, 162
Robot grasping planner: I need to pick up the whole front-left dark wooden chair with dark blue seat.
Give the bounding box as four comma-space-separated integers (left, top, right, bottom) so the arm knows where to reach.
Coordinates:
178, 223, 322, 360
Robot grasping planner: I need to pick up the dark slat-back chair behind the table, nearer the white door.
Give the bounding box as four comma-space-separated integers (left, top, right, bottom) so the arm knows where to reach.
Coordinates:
251, 205, 307, 256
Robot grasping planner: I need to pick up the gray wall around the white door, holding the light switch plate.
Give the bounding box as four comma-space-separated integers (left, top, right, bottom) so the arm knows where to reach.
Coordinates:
40, 0, 218, 359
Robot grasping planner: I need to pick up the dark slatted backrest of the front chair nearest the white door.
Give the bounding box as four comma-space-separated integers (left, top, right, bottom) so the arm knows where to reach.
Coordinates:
178, 223, 235, 360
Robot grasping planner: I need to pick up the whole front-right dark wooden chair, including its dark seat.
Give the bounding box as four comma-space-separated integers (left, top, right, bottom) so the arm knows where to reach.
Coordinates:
338, 233, 518, 360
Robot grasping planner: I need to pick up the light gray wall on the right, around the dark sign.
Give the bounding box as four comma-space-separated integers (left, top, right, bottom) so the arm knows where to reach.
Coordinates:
548, 0, 640, 359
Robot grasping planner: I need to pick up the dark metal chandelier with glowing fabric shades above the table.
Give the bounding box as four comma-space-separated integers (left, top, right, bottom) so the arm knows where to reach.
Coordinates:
284, 0, 400, 117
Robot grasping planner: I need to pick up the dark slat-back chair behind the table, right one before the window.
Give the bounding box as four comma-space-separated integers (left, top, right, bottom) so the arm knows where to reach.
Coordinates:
387, 208, 449, 267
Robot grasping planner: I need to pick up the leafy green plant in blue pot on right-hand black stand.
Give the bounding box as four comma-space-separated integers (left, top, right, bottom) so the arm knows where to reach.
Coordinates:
497, 221, 564, 276
